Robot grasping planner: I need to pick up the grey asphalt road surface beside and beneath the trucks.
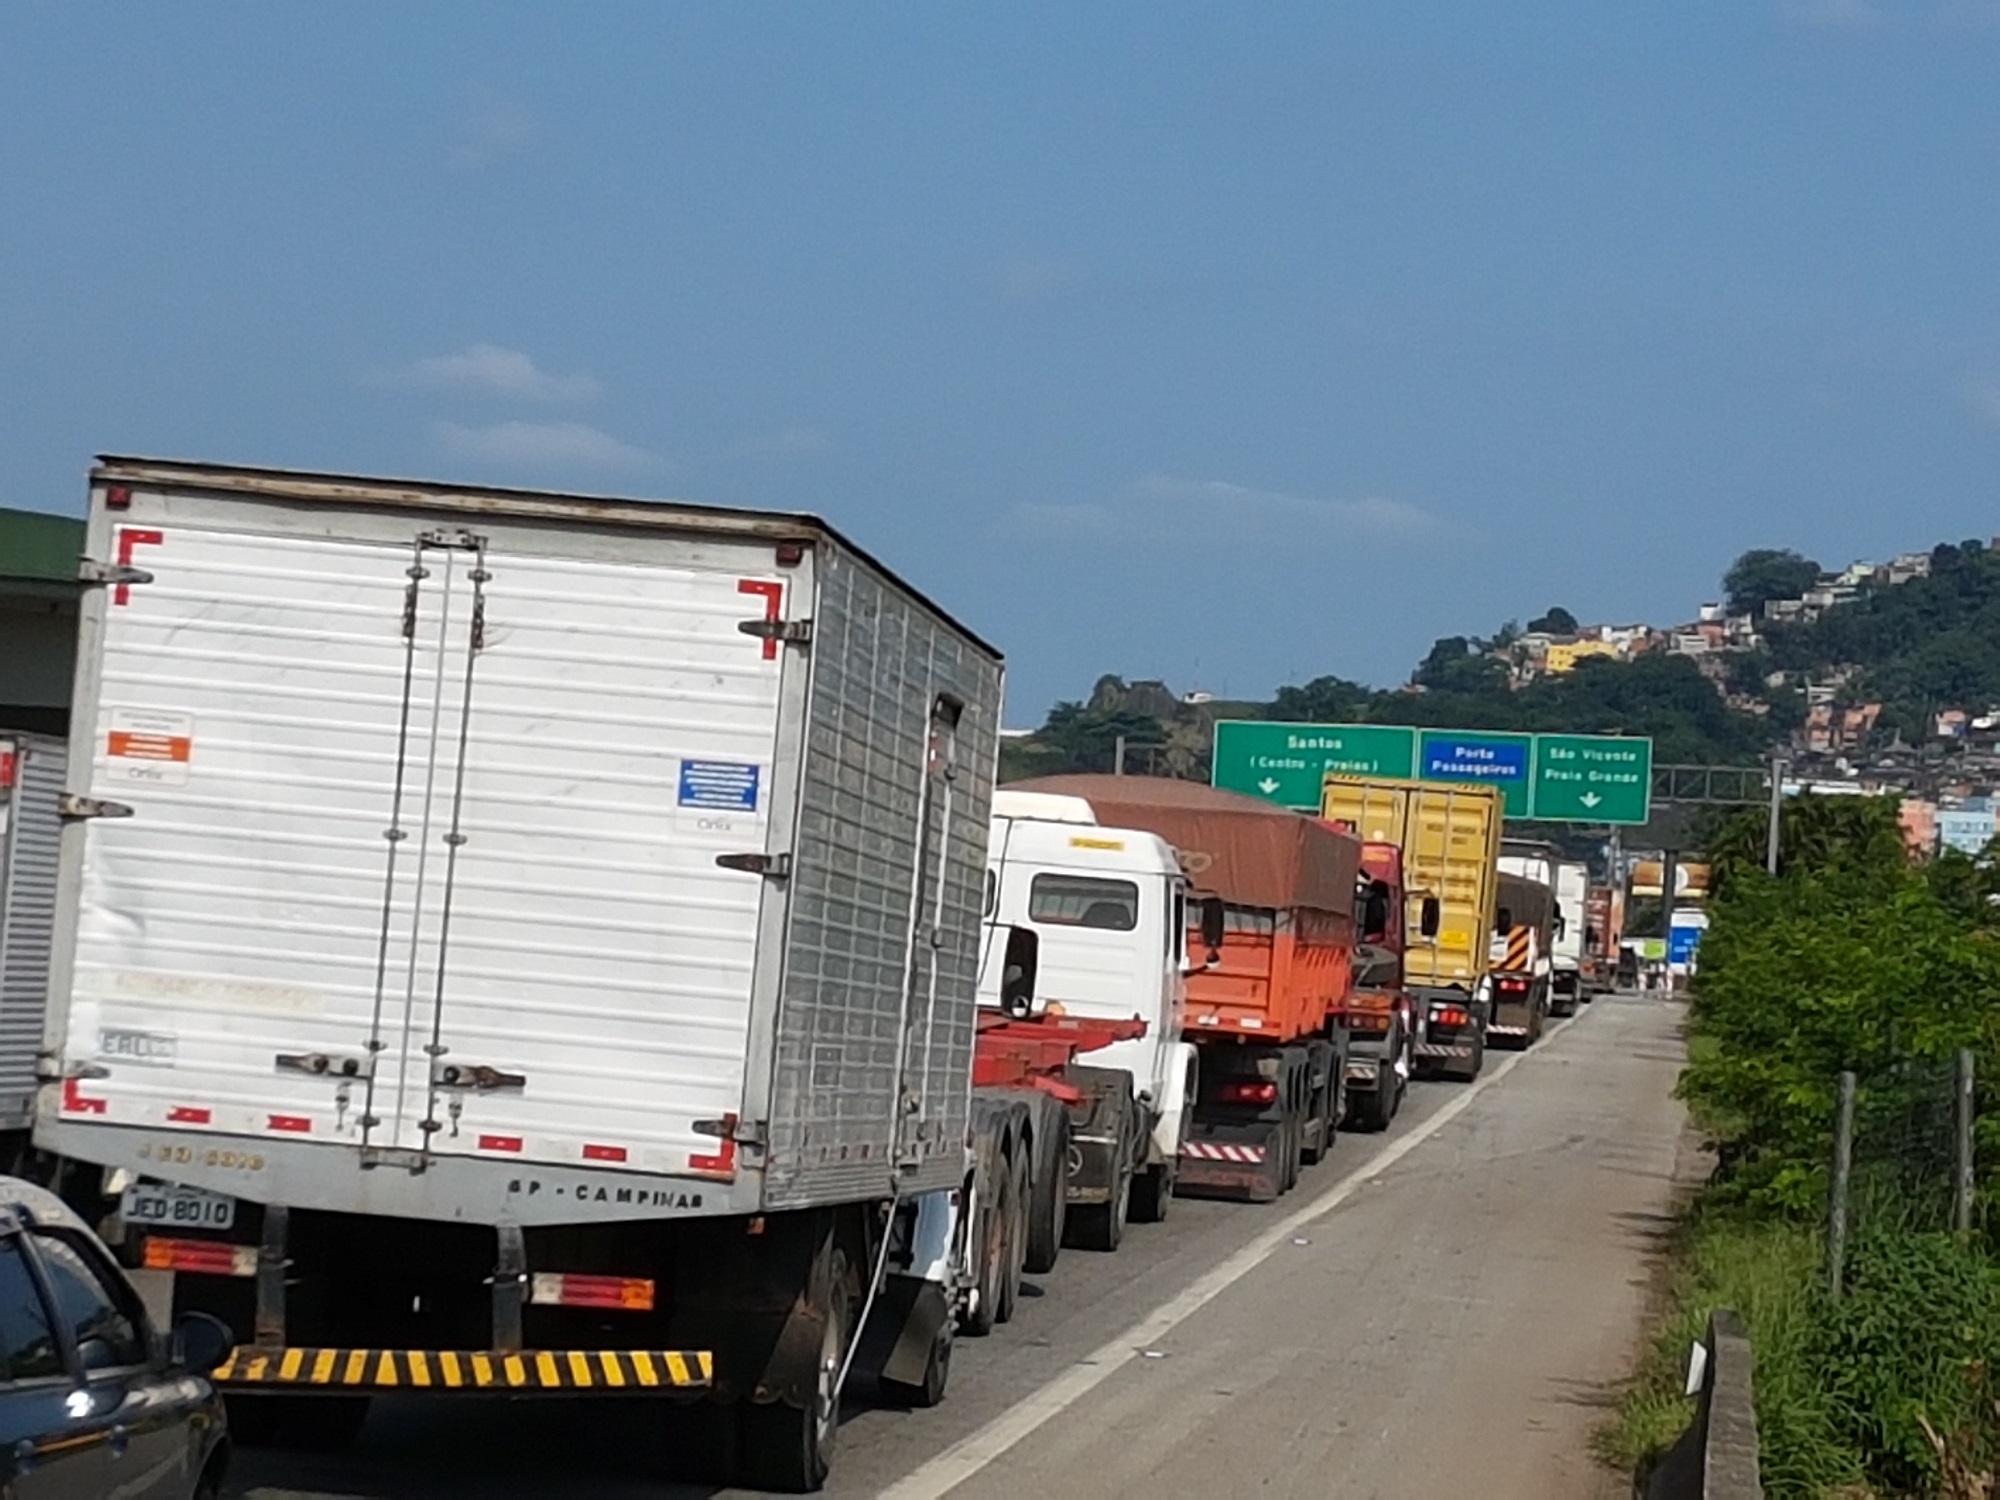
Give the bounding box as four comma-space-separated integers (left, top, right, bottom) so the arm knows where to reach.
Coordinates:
230, 998, 1682, 1500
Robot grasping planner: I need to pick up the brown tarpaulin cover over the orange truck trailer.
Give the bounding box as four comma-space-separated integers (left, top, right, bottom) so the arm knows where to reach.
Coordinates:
1008, 776, 1362, 916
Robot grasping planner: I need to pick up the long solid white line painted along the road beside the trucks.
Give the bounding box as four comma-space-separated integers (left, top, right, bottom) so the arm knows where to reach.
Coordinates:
880, 1018, 1574, 1500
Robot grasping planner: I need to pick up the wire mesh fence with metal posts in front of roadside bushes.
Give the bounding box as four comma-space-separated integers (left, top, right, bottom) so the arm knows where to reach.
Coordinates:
1826, 1050, 2000, 1296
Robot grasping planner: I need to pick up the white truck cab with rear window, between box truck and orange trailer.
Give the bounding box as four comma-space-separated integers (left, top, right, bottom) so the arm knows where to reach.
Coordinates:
974, 788, 1196, 1272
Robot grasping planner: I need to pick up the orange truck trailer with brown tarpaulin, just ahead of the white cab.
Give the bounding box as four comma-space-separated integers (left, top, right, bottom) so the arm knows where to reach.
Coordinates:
1004, 776, 1362, 1202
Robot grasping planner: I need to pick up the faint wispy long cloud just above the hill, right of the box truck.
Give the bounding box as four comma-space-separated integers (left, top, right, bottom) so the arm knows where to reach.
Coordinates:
1008, 474, 1438, 546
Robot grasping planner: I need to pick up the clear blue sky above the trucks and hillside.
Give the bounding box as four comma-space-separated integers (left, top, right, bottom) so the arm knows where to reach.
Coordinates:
0, 0, 2000, 722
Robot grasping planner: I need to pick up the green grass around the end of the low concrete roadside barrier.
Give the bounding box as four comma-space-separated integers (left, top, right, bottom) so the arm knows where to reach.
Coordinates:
1596, 1200, 1866, 1500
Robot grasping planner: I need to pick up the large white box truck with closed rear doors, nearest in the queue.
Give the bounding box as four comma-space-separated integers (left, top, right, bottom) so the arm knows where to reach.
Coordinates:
47, 458, 1002, 1488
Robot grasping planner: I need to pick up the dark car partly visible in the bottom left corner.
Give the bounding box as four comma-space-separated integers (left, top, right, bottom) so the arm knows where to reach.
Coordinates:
0, 1178, 234, 1500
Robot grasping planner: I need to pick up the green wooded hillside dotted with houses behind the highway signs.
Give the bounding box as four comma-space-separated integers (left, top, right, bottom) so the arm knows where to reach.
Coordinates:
1004, 540, 2000, 844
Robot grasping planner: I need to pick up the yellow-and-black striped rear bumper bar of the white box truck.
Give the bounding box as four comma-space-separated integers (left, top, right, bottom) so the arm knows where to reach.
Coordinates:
212, 1344, 714, 1396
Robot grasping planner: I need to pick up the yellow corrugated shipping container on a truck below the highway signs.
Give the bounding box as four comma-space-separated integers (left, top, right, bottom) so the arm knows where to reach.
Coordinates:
1320, 774, 1502, 992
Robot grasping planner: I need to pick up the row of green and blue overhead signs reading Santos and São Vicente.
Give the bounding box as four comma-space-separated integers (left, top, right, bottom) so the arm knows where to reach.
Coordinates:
1210, 718, 1652, 824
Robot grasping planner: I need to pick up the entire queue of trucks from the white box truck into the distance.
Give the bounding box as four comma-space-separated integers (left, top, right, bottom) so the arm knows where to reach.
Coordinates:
0, 458, 1616, 1490
